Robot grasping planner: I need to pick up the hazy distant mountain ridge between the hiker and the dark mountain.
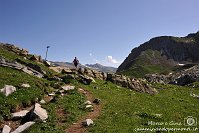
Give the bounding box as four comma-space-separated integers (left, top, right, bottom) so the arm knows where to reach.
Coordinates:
85, 63, 117, 73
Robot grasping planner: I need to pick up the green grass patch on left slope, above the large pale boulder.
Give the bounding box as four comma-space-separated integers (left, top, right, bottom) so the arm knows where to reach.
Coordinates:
0, 67, 50, 117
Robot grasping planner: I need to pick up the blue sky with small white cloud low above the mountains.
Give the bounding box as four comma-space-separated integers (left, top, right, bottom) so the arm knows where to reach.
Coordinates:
0, 0, 199, 66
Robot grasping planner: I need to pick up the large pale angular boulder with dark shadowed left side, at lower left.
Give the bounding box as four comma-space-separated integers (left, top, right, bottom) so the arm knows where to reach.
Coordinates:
22, 103, 48, 123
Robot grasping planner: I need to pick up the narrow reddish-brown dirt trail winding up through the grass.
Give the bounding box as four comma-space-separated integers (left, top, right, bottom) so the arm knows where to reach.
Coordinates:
66, 89, 101, 133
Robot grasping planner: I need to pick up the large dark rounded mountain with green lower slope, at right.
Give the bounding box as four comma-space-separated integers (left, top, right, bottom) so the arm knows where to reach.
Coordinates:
117, 32, 199, 77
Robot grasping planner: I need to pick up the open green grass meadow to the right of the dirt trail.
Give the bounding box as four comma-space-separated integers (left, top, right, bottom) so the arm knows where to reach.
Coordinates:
74, 81, 199, 133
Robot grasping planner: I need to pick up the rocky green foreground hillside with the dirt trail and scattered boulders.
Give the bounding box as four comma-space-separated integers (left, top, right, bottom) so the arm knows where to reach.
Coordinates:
0, 43, 199, 133
